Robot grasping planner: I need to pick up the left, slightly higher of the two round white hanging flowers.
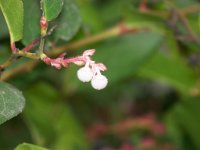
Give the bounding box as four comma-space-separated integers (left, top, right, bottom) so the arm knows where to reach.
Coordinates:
77, 66, 93, 82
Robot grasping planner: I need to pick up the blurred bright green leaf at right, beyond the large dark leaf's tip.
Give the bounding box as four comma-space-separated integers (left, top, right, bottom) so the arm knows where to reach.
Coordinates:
138, 31, 196, 94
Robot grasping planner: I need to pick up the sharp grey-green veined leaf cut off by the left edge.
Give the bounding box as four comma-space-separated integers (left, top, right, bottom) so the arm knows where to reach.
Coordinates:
0, 82, 25, 124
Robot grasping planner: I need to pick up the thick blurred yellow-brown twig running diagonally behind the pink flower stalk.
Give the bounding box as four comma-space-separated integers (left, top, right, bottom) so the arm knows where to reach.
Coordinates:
0, 24, 144, 81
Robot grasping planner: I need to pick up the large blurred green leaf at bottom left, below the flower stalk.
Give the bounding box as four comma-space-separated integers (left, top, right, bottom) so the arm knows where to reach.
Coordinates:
24, 83, 88, 150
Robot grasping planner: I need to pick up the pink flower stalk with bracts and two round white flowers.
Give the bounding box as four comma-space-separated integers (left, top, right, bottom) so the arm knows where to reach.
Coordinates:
41, 49, 108, 90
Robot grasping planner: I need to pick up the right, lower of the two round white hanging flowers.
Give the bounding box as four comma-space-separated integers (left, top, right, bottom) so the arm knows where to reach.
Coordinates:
91, 74, 108, 90
